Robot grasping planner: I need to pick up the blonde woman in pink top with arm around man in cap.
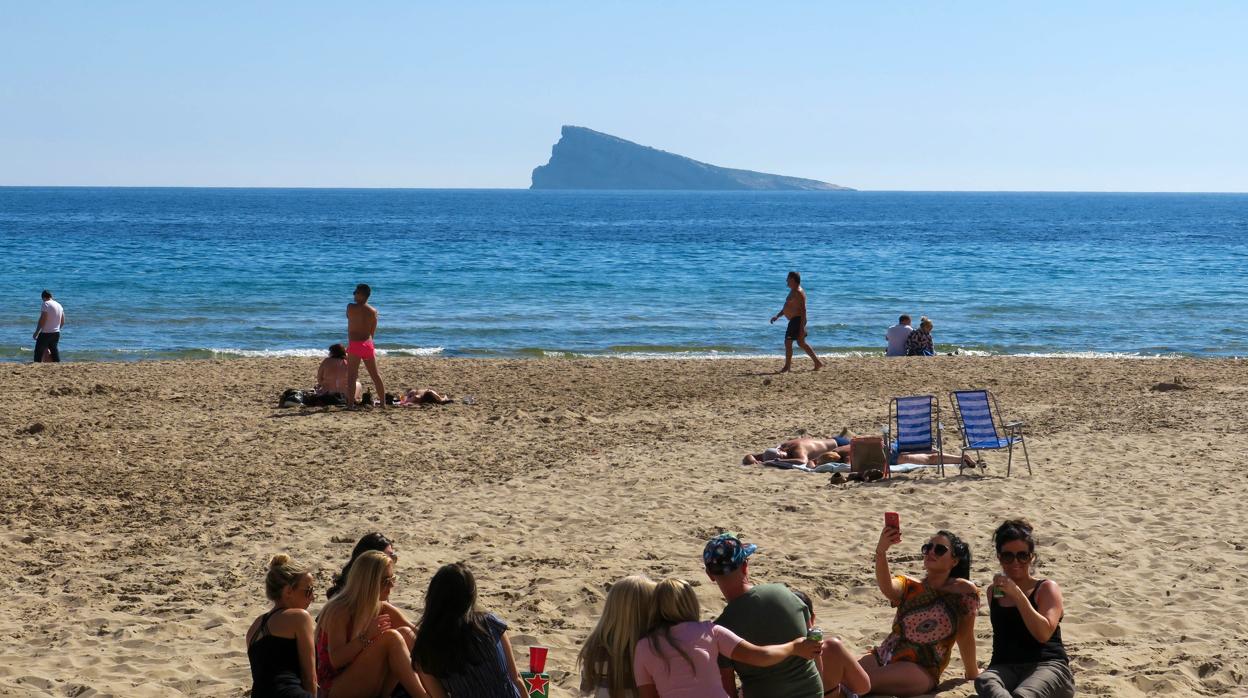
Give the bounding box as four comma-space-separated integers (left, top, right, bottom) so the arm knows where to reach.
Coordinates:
633, 579, 821, 698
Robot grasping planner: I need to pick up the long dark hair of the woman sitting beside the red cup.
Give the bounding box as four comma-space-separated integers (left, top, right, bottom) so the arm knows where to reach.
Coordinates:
412, 562, 494, 677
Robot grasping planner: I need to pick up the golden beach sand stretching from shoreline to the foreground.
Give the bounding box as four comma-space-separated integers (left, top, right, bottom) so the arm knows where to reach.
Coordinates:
0, 357, 1248, 697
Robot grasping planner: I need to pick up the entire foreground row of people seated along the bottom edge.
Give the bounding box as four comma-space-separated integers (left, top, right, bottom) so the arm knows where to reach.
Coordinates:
246, 519, 1075, 698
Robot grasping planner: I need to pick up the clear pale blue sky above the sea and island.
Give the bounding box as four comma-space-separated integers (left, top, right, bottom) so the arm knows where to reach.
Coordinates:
0, 0, 1248, 191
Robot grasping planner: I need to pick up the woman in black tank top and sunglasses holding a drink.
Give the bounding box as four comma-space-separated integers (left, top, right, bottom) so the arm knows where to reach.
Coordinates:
975, 519, 1075, 698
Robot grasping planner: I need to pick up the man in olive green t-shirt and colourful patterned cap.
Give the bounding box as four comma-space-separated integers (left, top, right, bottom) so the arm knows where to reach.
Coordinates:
703, 533, 824, 698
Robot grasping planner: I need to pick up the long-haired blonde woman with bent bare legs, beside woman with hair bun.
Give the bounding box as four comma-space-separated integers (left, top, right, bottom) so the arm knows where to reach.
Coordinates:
316, 551, 428, 698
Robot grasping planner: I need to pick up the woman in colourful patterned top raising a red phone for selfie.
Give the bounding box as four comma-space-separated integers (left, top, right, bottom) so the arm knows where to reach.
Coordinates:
822, 526, 980, 698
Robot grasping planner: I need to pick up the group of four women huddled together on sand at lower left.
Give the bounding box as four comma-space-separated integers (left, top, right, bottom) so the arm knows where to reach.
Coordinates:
246, 533, 524, 698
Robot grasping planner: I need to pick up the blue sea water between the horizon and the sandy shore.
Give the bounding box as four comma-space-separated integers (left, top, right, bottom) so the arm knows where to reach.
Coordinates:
0, 187, 1248, 361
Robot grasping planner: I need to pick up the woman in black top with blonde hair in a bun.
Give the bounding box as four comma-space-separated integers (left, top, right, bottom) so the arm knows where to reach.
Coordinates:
247, 554, 317, 698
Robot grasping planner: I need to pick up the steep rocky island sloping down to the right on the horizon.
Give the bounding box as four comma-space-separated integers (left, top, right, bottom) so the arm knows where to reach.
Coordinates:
530, 126, 854, 191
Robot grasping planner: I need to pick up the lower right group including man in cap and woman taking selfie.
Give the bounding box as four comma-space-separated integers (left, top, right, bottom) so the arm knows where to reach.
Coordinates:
577, 519, 1075, 698
